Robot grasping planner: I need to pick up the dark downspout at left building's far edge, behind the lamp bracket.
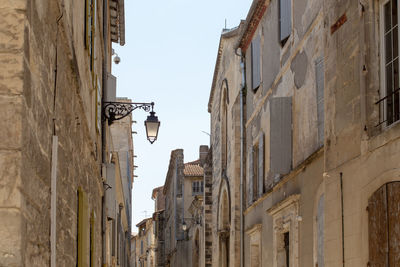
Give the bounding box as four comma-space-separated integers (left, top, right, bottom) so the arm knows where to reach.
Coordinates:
101, 0, 108, 266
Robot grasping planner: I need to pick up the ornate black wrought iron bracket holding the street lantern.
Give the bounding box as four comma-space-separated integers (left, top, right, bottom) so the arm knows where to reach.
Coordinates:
103, 102, 154, 125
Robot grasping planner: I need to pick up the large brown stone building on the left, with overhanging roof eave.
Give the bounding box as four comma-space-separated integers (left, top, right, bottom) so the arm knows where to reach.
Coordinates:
0, 0, 136, 266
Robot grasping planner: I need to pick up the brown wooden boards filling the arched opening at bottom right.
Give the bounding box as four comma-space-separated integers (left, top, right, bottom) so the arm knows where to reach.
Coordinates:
368, 182, 400, 267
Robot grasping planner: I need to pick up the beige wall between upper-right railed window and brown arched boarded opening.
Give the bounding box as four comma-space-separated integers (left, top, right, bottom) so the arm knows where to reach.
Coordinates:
324, 0, 400, 266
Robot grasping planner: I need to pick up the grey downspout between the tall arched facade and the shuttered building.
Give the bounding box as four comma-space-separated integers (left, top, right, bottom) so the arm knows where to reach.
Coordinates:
235, 49, 246, 267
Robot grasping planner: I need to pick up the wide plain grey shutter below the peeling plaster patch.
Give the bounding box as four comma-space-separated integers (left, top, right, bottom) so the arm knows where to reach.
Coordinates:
270, 97, 292, 176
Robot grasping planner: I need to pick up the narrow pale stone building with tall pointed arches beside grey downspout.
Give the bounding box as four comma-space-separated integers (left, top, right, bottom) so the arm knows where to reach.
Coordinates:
208, 23, 243, 266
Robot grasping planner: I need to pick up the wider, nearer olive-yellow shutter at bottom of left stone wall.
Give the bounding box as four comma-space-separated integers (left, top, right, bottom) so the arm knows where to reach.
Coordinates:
78, 187, 89, 267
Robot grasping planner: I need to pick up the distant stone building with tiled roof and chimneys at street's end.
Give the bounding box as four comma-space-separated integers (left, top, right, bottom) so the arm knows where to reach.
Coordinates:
160, 149, 208, 267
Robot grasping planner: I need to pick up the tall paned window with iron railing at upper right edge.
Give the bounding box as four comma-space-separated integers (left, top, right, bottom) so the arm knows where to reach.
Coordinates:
377, 0, 400, 125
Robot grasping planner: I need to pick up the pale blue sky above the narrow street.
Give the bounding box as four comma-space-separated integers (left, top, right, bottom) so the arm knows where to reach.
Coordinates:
112, 0, 252, 232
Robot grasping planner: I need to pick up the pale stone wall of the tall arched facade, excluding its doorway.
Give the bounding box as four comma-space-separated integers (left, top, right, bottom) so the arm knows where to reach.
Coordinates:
205, 29, 241, 266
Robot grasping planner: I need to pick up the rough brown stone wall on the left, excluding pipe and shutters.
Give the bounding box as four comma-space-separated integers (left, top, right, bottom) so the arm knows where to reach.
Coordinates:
0, 0, 102, 266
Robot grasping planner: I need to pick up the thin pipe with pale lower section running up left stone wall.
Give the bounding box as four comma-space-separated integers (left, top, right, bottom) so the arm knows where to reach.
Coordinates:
50, 13, 64, 267
